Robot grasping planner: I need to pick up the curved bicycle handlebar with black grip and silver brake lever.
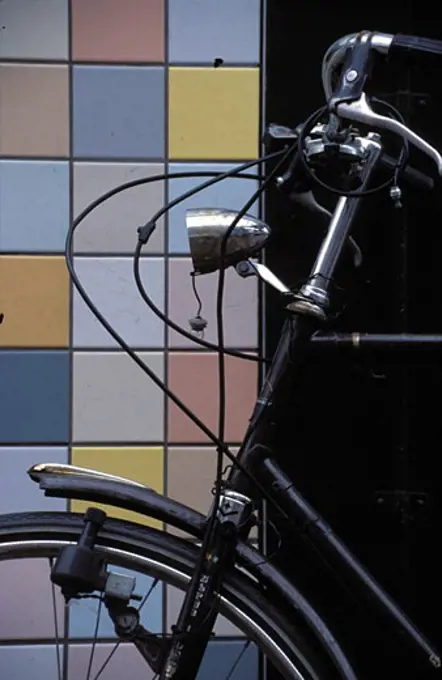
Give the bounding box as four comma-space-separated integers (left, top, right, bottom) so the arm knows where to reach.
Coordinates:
322, 31, 442, 175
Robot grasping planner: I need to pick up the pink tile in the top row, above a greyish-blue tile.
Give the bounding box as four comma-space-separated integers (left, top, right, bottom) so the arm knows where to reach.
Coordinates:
72, 0, 165, 62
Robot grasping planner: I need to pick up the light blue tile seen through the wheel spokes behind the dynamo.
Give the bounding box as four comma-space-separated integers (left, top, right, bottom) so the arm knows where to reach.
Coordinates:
69, 565, 163, 638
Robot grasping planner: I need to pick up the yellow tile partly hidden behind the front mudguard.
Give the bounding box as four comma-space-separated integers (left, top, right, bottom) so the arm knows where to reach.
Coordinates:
71, 446, 164, 528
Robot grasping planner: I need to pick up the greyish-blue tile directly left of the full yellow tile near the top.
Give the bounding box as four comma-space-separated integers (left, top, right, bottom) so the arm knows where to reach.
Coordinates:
73, 66, 165, 159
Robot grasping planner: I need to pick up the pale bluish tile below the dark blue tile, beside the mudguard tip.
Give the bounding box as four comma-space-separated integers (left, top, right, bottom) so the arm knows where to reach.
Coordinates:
0, 446, 68, 510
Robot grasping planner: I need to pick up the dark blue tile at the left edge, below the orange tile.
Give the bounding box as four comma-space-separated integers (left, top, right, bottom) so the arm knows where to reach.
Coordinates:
0, 351, 70, 444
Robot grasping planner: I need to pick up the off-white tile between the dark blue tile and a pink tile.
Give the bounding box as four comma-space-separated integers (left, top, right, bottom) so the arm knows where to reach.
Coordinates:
73, 352, 164, 444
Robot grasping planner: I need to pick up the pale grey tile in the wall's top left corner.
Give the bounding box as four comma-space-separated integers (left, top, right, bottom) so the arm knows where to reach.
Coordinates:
0, 0, 68, 59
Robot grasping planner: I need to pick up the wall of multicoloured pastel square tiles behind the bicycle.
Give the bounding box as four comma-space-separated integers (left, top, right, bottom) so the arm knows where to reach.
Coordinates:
0, 0, 261, 680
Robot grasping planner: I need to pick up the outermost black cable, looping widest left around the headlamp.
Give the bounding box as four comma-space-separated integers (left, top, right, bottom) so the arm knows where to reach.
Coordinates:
65, 165, 286, 516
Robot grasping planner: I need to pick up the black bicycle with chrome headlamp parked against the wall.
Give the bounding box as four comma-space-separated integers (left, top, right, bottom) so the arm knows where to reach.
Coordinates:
0, 31, 442, 680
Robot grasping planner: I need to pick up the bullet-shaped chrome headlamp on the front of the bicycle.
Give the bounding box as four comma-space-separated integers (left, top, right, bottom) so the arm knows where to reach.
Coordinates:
186, 208, 270, 274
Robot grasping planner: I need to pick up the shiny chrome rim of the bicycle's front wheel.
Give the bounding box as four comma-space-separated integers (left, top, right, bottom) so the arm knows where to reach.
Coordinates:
0, 540, 306, 680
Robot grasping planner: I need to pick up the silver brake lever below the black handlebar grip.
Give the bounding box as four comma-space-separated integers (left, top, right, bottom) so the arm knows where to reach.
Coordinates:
336, 92, 442, 176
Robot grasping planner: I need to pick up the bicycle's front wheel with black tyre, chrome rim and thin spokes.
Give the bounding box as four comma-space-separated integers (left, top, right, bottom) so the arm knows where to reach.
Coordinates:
0, 513, 338, 680
